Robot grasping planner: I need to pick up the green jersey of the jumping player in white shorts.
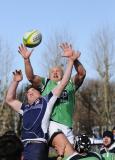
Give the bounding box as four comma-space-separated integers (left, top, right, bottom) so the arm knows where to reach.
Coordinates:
42, 80, 75, 128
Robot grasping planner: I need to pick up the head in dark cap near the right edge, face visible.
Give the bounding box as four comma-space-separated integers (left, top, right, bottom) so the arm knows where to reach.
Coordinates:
103, 131, 114, 148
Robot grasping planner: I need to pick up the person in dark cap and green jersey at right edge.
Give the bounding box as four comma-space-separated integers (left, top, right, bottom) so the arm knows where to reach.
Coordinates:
100, 131, 115, 160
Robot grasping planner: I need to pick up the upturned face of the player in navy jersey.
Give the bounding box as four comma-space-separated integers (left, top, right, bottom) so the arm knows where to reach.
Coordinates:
26, 88, 40, 104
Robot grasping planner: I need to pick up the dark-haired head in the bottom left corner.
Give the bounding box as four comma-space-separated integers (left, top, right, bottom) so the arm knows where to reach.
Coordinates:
0, 132, 24, 160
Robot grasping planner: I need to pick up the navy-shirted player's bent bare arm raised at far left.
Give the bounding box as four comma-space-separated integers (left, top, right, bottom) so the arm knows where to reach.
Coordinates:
6, 70, 23, 112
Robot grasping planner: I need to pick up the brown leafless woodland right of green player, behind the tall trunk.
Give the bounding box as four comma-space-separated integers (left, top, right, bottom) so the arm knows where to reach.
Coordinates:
74, 80, 115, 135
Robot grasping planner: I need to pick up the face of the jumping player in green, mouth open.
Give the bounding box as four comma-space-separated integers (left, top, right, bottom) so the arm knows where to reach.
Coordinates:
49, 67, 63, 82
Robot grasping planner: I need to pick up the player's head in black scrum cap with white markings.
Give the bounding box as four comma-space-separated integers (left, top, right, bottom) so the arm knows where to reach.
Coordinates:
75, 134, 91, 153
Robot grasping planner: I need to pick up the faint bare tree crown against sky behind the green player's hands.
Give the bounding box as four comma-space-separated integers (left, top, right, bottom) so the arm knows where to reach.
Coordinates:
39, 31, 73, 75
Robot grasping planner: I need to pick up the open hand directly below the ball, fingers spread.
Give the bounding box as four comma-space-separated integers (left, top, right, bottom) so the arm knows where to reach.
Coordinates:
18, 44, 33, 59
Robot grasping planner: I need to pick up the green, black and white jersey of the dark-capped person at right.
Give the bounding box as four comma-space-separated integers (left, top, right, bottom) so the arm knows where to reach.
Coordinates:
100, 143, 115, 160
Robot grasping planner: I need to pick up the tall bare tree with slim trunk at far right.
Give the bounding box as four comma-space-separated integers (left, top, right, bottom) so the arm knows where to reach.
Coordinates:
91, 28, 115, 128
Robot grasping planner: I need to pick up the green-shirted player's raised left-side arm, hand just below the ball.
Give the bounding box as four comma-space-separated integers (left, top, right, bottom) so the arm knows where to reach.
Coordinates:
18, 44, 41, 86
